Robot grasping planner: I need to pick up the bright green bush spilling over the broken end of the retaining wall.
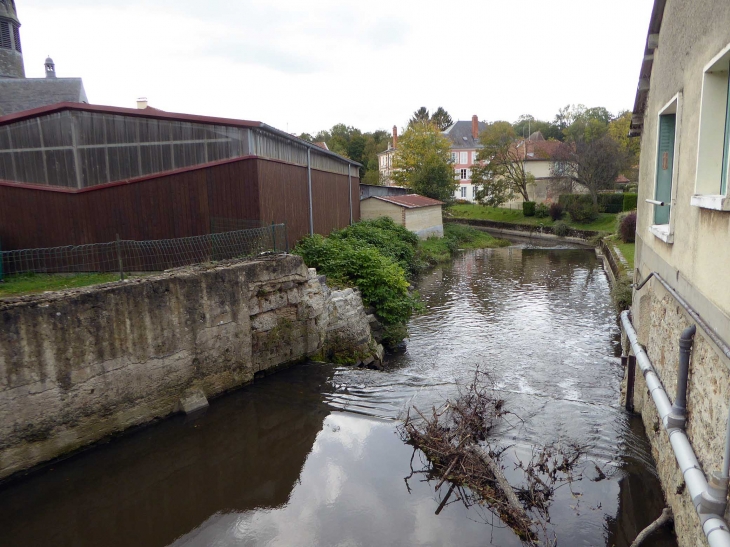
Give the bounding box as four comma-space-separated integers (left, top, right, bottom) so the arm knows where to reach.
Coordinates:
294, 235, 418, 325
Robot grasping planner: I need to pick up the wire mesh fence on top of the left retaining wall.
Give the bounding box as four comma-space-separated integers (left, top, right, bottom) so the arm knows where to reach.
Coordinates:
0, 224, 289, 279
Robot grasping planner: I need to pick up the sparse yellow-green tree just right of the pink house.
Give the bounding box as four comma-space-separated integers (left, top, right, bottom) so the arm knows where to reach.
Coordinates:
471, 122, 535, 204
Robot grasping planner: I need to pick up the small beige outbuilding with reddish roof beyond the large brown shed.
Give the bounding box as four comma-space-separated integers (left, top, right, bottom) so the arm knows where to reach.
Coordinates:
360, 194, 444, 239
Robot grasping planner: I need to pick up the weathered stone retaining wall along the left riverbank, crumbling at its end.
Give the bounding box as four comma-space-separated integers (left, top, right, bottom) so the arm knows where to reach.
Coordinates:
0, 255, 382, 478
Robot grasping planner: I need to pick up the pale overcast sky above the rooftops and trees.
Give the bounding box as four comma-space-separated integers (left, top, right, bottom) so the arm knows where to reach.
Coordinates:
16, 0, 653, 134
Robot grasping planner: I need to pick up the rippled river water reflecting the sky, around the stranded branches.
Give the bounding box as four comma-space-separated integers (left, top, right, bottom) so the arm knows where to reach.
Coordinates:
0, 246, 676, 547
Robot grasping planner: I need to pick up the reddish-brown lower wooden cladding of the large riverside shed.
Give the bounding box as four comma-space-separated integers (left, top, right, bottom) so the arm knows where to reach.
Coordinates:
0, 158, 360, 250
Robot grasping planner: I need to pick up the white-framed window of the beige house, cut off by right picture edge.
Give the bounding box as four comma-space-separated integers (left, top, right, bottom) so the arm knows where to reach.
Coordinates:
690, 40, 730, 211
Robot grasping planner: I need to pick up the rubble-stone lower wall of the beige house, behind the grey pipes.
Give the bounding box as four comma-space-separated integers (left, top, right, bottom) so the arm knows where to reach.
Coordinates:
633, 280, 730, 547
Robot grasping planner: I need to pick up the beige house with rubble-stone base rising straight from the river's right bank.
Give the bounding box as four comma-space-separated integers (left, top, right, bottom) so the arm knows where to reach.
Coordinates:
622, 0, 730, 547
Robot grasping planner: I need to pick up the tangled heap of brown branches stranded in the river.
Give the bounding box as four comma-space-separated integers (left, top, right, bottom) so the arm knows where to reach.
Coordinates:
400, 369, 588, 545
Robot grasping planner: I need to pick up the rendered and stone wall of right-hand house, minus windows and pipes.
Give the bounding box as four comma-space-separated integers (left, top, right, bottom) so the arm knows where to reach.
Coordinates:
632, 0, 730, 547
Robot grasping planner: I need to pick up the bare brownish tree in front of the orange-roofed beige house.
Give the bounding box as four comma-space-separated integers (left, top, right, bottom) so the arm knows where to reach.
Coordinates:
550, 135, 626, 210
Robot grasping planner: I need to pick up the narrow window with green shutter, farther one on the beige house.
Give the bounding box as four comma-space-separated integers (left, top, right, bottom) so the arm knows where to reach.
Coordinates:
649, 93, 682, 243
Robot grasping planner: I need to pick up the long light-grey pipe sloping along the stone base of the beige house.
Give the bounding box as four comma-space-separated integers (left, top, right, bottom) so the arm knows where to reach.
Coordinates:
621, 311, 730, 547
